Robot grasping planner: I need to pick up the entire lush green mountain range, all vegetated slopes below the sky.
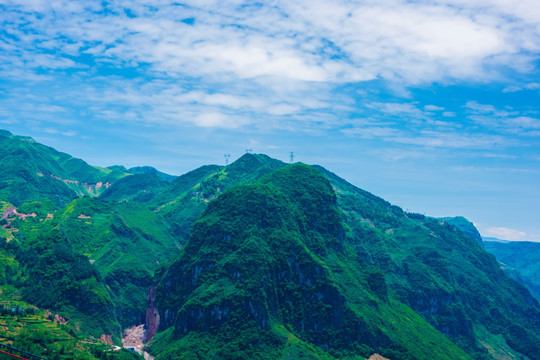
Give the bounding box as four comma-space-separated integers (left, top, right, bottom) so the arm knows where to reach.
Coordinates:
0, 131, 540, 360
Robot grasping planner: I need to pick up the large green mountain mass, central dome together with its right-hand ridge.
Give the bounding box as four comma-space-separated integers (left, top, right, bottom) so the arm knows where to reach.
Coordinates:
150, 164, 540, 359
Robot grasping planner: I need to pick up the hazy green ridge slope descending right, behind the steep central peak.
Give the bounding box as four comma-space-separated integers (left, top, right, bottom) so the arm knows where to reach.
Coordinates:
321, 169, 540, 359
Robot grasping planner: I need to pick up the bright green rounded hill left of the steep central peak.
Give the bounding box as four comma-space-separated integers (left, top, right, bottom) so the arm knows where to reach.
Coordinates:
6, 198, 179, 334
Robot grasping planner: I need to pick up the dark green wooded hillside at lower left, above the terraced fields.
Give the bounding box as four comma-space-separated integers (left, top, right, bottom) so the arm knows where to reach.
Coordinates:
0, 232, 120, 340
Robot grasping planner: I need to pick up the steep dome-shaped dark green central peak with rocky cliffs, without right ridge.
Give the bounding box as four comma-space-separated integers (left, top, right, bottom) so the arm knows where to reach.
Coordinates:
151, 165, 469, 359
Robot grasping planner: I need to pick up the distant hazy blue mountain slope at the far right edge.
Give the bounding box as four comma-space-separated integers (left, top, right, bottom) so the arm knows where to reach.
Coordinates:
484, 241, 540, 301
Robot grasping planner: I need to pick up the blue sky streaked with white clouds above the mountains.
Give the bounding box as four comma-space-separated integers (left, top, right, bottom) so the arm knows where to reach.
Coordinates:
0, 0, 540, 241
